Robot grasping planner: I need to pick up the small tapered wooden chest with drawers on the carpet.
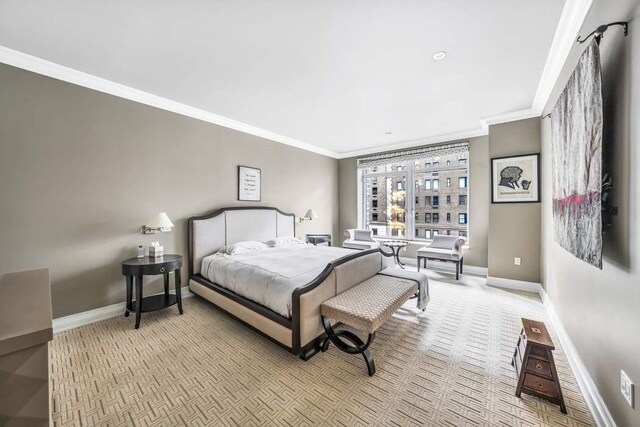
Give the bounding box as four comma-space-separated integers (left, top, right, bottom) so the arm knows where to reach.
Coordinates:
511, 319, 567, 414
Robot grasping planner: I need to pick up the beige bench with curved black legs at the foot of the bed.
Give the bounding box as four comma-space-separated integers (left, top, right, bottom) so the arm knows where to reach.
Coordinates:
320, 274, 418, 376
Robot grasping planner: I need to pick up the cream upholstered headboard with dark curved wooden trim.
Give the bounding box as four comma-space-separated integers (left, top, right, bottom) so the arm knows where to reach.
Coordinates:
189, 207, 296, 274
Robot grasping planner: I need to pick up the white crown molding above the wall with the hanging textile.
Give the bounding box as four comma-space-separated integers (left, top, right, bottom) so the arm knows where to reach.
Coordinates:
532, 0, 593, 115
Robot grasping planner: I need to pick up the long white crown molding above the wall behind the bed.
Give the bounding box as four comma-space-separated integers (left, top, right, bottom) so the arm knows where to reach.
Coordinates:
0, 45, 338, 158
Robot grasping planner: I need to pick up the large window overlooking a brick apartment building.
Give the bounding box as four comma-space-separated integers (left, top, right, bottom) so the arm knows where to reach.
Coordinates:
358, 143, 469, 240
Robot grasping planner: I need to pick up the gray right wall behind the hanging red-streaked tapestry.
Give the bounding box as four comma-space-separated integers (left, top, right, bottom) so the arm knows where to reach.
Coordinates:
542, 0, 640, 427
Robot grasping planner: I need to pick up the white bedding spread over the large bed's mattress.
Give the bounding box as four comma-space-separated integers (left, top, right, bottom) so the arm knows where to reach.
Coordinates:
201, 244, 354, 317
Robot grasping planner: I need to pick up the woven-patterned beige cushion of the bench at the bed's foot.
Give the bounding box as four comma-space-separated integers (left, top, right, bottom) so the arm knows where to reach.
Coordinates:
320, 275, 418, 334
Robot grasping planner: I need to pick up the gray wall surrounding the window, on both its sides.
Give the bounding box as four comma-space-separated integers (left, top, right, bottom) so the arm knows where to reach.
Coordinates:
339, 136, 489, 267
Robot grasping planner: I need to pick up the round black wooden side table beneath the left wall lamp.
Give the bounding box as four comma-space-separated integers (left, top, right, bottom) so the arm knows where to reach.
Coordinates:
122, 255, 183, 329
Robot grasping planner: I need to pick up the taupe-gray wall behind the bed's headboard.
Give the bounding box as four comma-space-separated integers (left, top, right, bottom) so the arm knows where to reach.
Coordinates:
0, 65, 338, 317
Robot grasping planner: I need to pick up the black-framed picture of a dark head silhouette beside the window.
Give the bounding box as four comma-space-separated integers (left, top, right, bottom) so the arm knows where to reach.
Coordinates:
491, 153, 541, 203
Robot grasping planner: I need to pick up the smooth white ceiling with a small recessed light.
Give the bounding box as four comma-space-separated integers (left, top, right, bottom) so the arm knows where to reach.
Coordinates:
0, 0, 564, 157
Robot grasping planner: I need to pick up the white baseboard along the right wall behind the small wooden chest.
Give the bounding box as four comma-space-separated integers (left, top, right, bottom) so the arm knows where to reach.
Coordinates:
540, 287, 616, 427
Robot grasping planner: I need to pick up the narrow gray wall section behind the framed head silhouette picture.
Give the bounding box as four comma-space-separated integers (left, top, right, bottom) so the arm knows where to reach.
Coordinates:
488, 118, 550, 283
